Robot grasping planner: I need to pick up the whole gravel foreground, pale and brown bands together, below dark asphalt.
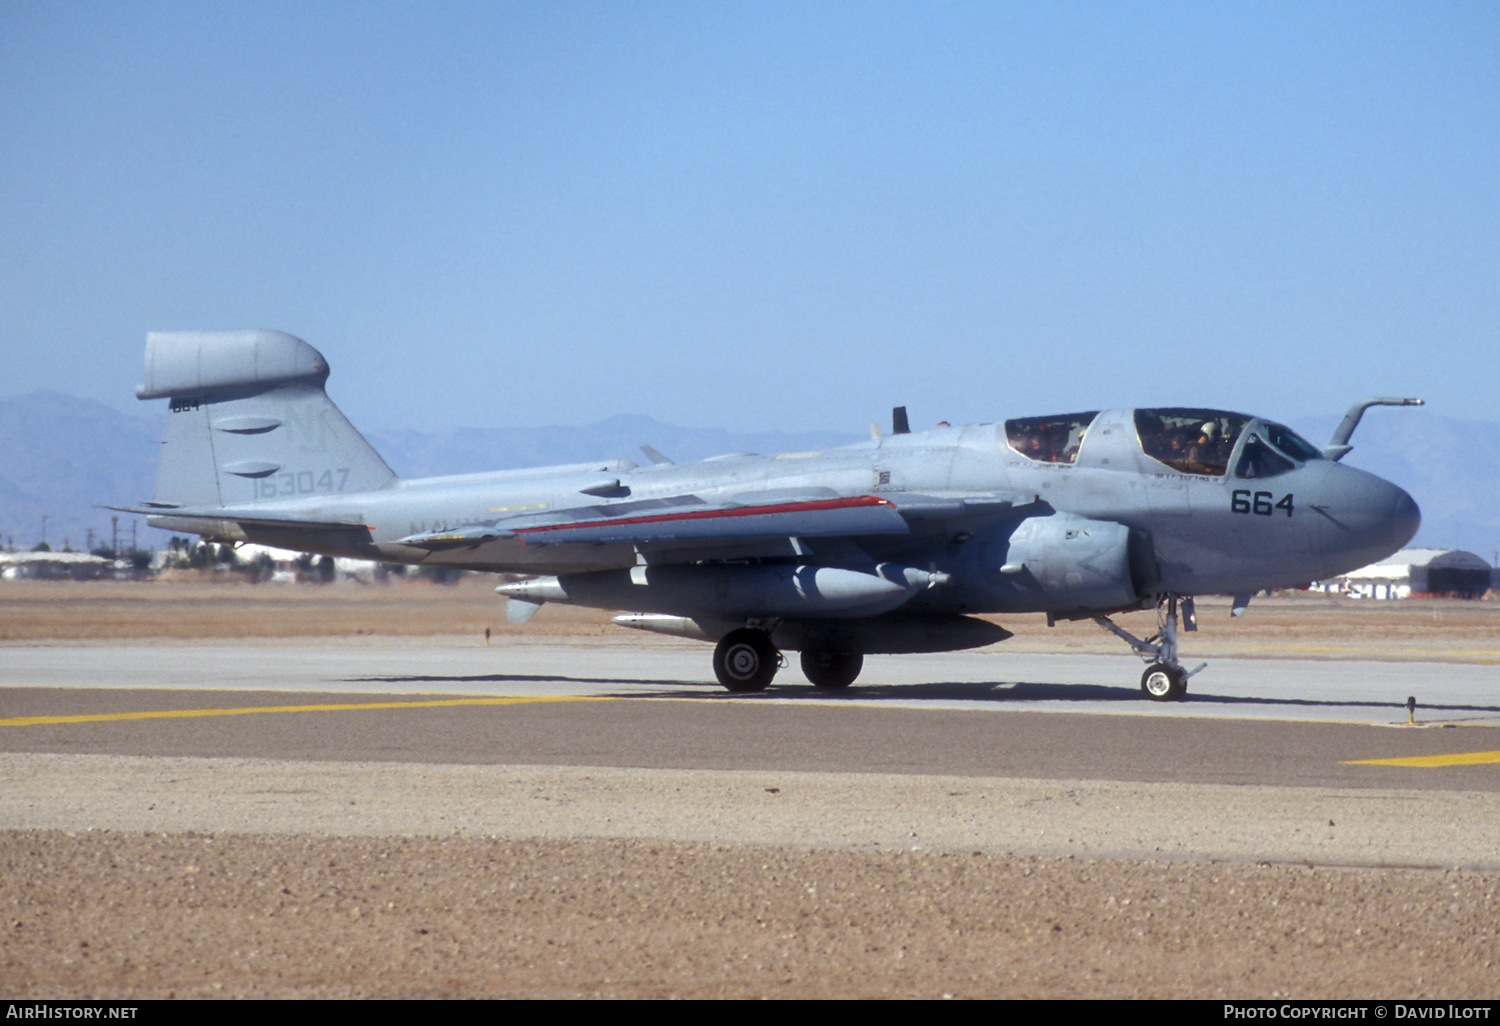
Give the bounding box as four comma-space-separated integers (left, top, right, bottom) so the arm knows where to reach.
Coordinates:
0, 755, 1500, 1001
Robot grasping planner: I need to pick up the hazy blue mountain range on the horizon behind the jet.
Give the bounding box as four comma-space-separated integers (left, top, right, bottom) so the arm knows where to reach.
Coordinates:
0, 392, 1500, 563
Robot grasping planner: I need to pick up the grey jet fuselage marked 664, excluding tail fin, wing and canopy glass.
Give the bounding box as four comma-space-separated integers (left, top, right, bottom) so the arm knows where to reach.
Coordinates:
153, 410, 1418, 612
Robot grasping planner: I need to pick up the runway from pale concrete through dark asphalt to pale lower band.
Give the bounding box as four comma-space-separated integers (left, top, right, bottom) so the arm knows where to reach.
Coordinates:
0, 638, 1500, 872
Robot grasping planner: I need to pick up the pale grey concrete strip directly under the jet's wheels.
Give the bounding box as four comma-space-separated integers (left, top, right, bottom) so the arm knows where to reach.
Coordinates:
0, 635, 1500, 726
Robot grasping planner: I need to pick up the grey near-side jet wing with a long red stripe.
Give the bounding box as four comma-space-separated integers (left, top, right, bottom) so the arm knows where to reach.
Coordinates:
401, 494, 908, 549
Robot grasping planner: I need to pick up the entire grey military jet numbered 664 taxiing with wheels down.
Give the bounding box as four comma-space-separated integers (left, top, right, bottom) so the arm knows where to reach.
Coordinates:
120, 332, 1421, 701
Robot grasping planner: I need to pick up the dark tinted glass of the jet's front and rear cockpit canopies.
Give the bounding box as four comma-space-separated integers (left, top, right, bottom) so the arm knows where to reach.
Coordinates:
1005, 407, 1323, 479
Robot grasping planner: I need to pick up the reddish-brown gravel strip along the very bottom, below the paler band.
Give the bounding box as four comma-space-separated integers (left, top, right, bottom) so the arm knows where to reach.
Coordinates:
0, 831, 1500, 999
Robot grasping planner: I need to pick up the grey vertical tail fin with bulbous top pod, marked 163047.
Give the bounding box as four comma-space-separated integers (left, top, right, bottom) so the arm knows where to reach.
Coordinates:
135, 332, 396, 512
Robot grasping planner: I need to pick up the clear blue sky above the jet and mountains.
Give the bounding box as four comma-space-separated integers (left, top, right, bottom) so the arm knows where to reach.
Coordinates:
0, 0, 1500, 432
